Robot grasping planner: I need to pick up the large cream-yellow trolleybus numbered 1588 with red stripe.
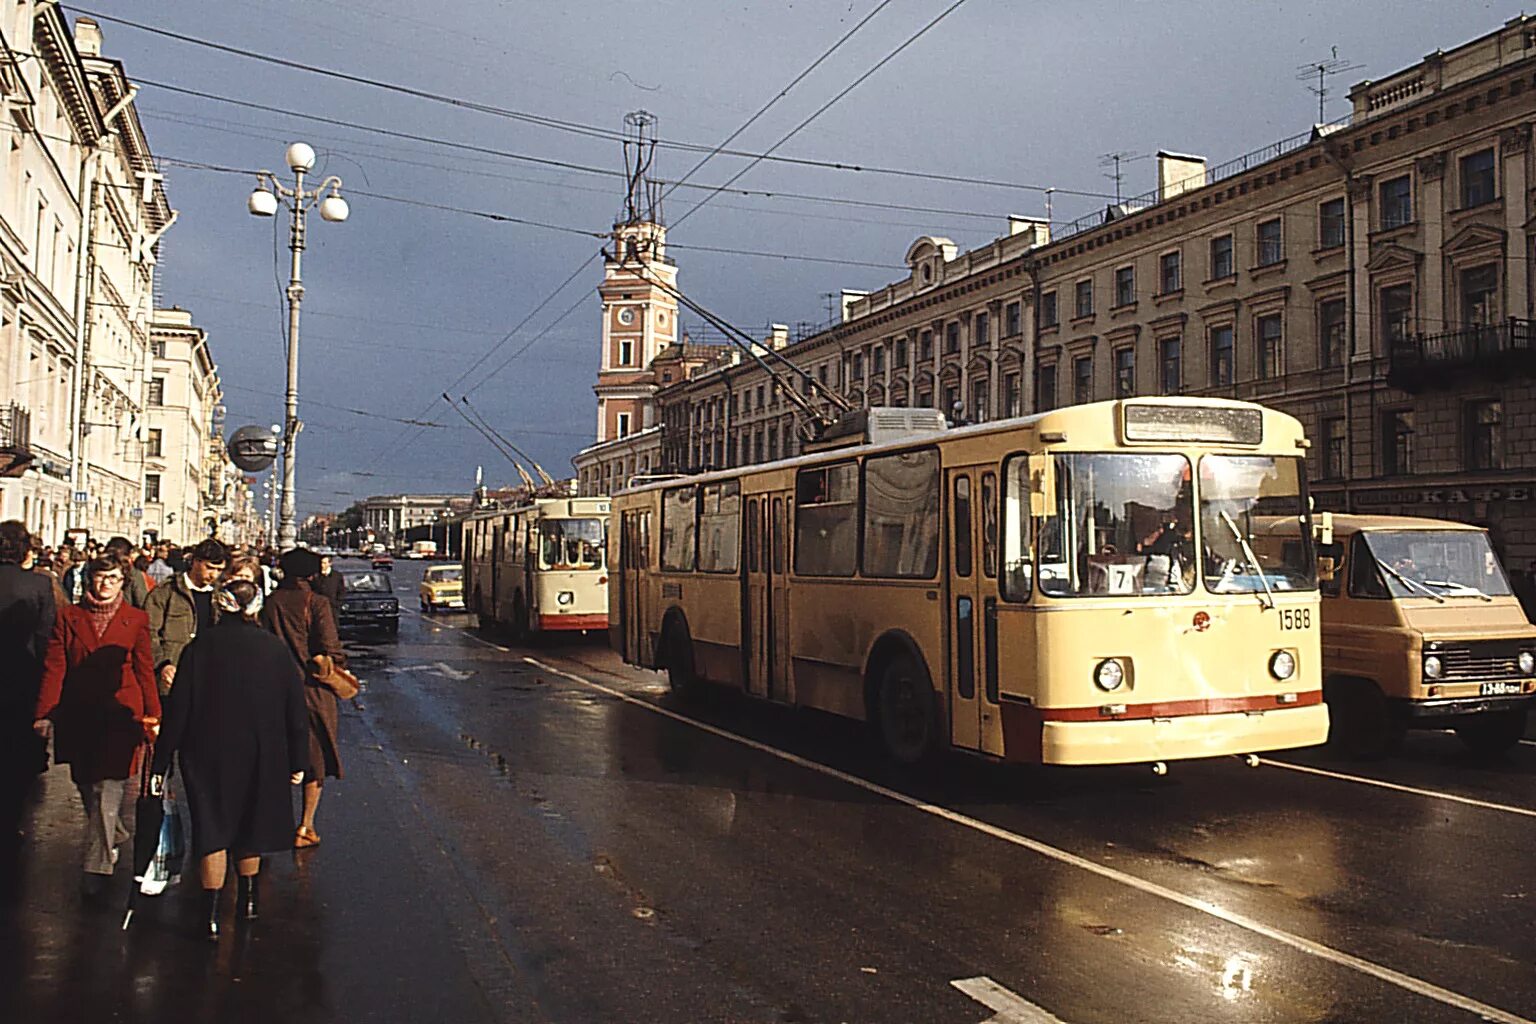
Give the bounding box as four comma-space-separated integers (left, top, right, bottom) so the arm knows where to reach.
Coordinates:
610, 398, 1329, 772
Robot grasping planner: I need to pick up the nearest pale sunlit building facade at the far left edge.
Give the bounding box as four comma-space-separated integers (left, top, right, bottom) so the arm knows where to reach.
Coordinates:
0, 11, 175, 542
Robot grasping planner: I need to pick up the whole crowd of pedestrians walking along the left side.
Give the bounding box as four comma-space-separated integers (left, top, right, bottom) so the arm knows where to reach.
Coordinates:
0, 520, 355, 940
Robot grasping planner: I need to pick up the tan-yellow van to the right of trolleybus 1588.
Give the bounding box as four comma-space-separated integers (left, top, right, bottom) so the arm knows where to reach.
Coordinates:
1284, 514, 1536, 757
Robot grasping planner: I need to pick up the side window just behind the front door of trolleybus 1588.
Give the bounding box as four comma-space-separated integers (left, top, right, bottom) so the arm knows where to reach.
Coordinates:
866, 448, 933, 579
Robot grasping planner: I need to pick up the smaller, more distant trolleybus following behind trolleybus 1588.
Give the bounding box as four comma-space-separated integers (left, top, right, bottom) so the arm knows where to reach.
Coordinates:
462, 497, 608, 637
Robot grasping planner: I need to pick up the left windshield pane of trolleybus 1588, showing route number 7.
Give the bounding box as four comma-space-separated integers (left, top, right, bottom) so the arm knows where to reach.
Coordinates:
1032, 454, 1195, 597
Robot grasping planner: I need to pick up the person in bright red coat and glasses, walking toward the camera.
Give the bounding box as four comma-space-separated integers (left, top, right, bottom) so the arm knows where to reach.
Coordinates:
37, 557, 160, 895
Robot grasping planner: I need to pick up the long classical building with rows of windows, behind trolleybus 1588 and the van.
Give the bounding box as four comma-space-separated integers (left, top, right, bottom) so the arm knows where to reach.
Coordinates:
656, 17, 1536, 565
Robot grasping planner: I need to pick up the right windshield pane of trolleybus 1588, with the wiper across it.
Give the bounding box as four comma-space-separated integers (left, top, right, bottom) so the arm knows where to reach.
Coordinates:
1200, 454, 1318, 594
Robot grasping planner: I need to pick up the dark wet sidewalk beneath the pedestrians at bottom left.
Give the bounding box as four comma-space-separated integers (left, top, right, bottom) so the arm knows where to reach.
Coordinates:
0, 709, 496, 1024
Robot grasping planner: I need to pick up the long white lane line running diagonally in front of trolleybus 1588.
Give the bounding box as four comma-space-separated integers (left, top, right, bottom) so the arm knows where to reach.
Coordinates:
522, 656, 1536, 1024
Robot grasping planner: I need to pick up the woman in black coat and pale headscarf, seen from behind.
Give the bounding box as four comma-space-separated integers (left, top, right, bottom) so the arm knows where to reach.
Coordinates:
152, 579, 309, 941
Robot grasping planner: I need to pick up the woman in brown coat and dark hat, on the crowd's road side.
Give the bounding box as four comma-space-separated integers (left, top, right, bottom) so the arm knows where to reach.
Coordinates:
261, 548, 346, 849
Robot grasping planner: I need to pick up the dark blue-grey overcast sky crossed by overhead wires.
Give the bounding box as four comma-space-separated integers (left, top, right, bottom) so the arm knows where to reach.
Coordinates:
66, 0, 1521, 517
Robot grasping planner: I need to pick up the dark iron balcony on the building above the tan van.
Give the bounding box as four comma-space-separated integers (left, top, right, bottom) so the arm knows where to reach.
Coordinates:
1387, 316, 1536, 391
